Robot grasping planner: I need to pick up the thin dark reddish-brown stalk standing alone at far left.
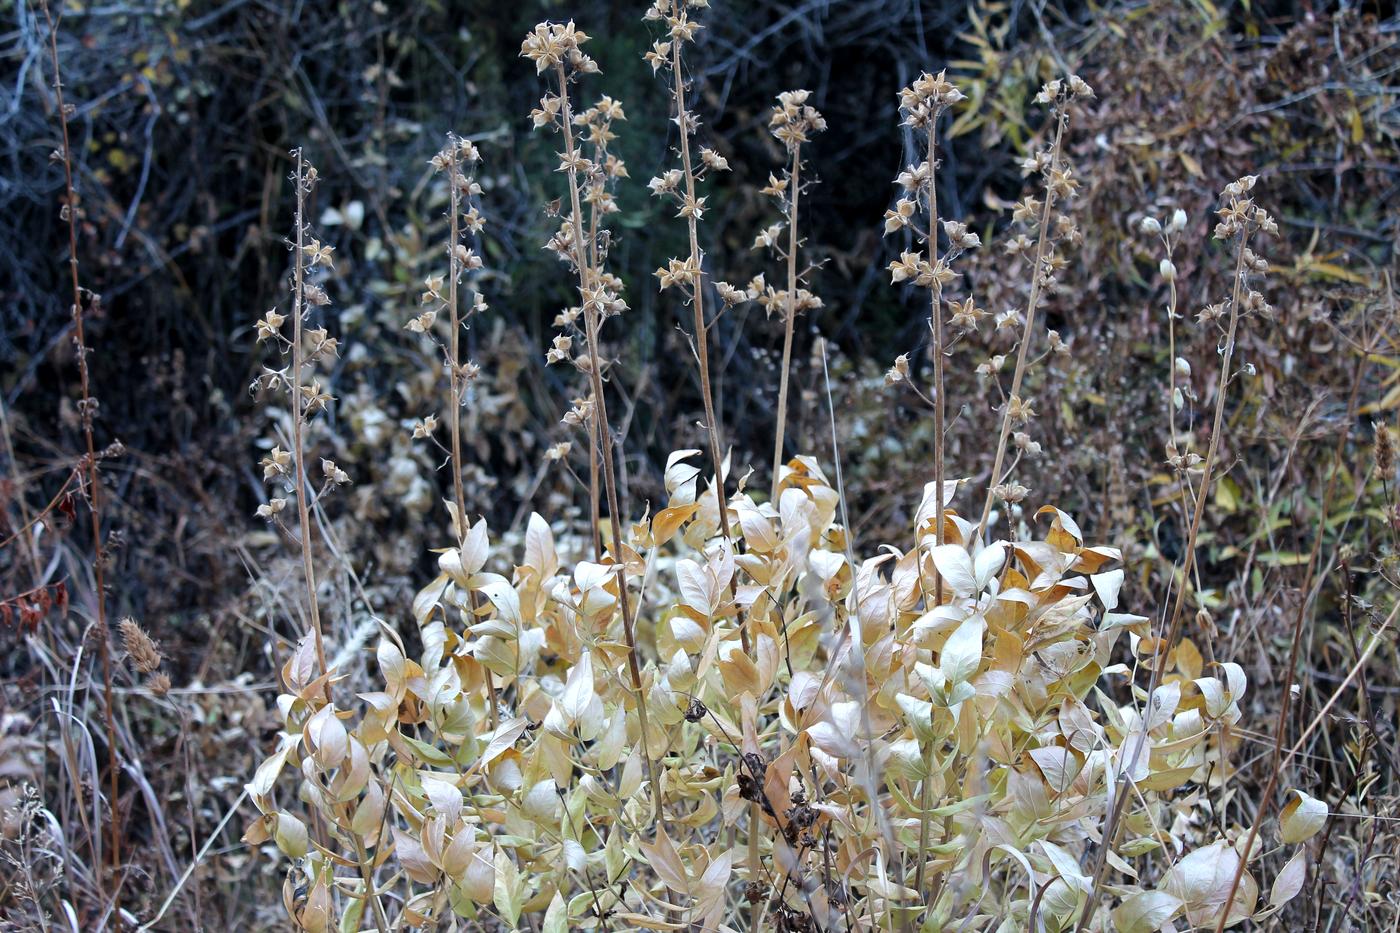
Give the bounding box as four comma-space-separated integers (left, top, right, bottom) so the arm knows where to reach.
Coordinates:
39, 0, 122, 907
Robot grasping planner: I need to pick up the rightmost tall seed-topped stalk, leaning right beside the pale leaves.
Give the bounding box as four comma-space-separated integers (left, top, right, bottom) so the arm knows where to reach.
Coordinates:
1075, 231, 1254, 933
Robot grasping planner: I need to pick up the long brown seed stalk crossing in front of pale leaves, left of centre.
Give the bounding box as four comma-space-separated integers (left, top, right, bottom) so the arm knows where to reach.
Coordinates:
554, 63, 664, 821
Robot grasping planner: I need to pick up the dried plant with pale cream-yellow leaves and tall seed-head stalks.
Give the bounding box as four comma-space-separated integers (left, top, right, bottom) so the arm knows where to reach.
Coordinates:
240, 23, 1326, 933
